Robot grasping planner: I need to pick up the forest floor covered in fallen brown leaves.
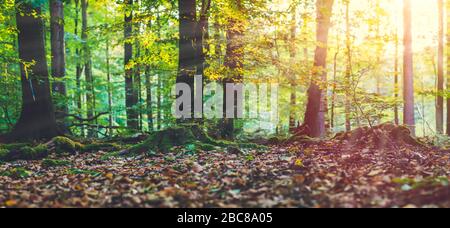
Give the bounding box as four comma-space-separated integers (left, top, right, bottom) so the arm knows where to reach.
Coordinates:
0, 127, 450, 208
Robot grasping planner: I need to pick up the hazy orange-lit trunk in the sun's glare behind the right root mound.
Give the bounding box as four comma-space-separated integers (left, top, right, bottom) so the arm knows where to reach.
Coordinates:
403, 0, 416, 135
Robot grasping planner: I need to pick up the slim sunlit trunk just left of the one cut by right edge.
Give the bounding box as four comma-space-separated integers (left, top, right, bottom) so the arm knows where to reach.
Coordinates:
436, 0, 445, 134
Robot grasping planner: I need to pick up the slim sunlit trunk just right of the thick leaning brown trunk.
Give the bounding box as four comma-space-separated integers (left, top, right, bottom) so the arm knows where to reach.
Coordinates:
344, 0, 352, 131
